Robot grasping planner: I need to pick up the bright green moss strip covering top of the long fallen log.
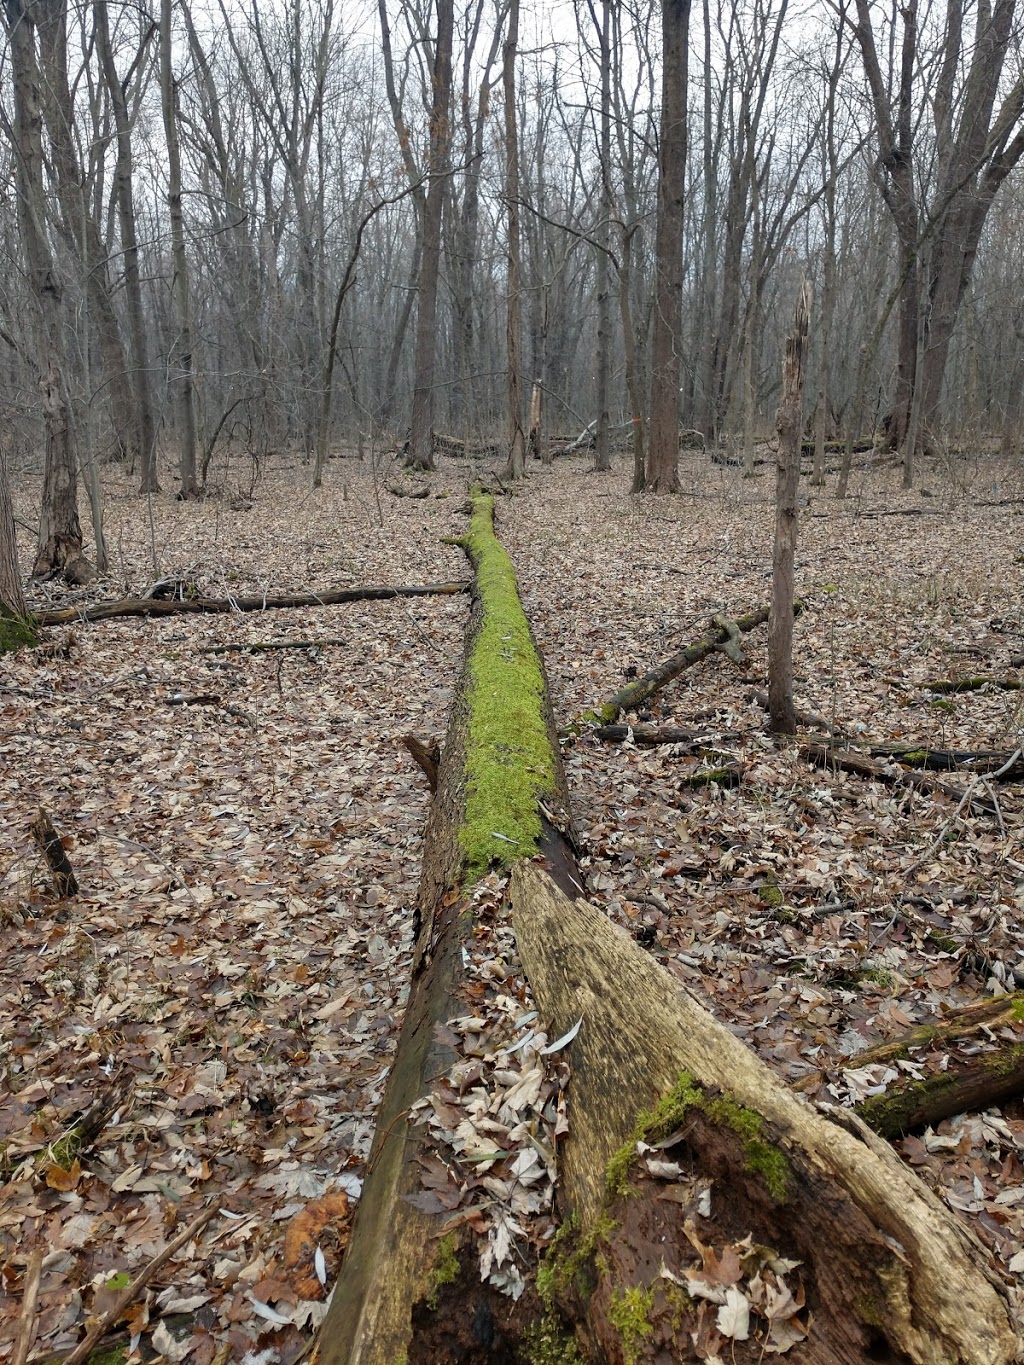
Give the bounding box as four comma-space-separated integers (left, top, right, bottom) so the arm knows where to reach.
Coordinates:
459, 494, 554, 885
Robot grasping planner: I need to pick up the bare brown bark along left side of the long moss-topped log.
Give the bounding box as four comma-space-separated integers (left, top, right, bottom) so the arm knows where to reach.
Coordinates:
318, 499, 578, 1365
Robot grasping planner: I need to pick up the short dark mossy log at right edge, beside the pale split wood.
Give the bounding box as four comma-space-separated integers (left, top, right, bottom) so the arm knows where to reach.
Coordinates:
848, 992, 1024, 1138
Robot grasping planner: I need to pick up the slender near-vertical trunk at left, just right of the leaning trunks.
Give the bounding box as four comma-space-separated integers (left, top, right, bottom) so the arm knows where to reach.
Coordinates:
160, 0, 198, 498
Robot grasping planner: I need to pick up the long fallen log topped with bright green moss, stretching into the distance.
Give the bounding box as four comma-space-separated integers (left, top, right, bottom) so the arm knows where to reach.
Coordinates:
317, 497, 578, 1365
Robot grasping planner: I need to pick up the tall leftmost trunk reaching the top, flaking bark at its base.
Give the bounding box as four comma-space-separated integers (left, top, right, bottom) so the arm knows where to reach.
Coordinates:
5, 0, 93, 583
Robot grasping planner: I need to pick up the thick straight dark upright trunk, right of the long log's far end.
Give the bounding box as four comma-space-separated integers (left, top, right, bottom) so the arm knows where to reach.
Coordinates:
647, 0, 689, 493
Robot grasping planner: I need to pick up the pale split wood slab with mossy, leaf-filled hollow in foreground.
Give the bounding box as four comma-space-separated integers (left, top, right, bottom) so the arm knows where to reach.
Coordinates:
511, 863, 1019, 1365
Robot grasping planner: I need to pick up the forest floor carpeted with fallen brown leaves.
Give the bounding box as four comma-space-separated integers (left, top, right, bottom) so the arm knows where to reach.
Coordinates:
0, 442, 1024, 1365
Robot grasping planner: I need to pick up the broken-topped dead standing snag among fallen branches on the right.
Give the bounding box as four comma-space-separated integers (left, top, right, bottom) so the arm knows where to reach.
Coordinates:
769, 280, 811, 734
